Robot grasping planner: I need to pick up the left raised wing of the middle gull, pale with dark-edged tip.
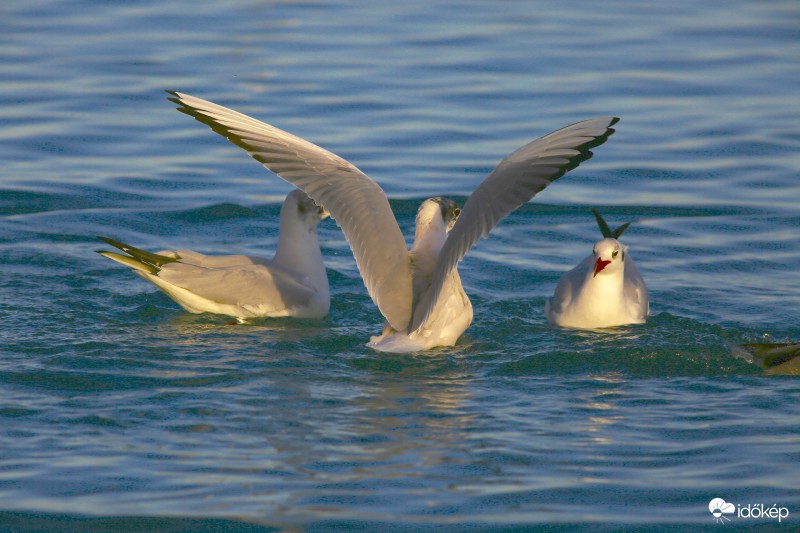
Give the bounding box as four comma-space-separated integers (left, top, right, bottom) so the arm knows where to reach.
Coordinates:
167, 91, 412, 331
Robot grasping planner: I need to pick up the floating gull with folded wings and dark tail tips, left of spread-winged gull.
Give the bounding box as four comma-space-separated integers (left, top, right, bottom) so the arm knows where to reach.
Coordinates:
97, 189, 331, 322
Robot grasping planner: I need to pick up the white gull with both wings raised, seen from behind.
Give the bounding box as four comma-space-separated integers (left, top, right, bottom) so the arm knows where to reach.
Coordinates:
168, 91, 619, 352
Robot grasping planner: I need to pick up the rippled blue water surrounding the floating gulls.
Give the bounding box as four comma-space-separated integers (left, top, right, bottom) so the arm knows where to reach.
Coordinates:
0, 0, 800, 531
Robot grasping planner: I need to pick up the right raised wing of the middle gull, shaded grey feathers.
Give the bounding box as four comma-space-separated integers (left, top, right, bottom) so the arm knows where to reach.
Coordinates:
411, 117, 619, 330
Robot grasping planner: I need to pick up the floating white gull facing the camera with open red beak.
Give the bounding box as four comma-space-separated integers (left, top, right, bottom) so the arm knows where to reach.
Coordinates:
544, 209, 650, 329
